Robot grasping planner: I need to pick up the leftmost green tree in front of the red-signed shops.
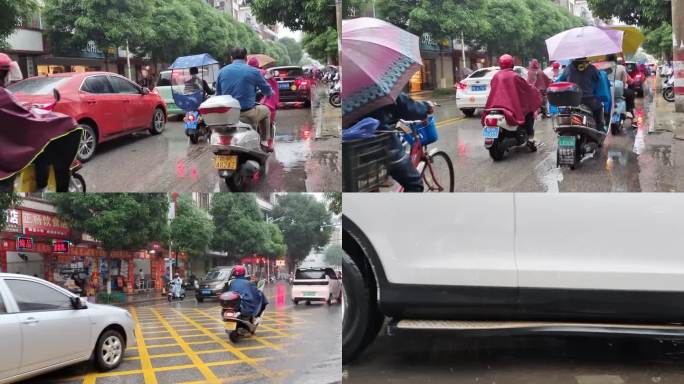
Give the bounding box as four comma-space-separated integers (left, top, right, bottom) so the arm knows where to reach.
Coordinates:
50, 193, 169, 293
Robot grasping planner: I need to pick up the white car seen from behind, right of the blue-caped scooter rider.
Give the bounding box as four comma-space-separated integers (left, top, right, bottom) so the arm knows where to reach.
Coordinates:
292, 268, 342, 304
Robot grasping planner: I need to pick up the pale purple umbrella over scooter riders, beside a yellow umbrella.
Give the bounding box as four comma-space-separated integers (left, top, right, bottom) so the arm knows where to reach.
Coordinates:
546, 27, 624, 61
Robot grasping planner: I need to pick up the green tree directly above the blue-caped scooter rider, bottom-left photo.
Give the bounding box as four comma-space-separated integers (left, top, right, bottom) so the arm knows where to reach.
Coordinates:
210, 193, 268, 258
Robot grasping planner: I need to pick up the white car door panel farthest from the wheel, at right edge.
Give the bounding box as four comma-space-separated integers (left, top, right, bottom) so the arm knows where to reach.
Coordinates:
516, 193, 684, 292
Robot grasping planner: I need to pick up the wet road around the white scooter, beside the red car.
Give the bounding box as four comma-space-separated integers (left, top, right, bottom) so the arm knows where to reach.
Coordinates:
81, 89, 340, 192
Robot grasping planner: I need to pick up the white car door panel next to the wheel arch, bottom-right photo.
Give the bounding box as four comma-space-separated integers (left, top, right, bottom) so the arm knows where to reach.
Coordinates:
343, 193, 517, 287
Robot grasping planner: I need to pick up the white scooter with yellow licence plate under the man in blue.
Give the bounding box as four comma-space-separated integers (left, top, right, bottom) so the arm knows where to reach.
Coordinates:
200, 95, 277, 192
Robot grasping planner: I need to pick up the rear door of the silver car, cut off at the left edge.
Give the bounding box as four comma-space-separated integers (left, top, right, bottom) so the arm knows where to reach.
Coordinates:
0, 280, 21, 380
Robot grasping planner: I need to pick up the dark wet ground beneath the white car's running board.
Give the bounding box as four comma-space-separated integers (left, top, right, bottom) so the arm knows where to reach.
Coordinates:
343, 328, 684, 384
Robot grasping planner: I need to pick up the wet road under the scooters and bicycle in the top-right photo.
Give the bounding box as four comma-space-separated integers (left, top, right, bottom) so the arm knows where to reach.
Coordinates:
412, 80, 676, 192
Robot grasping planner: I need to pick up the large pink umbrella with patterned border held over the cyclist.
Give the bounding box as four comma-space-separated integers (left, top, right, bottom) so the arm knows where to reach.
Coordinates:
340, 17, 422, 126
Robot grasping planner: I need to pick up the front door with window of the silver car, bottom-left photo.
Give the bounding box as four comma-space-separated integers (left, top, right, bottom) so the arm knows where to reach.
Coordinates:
5, 278, 94, 373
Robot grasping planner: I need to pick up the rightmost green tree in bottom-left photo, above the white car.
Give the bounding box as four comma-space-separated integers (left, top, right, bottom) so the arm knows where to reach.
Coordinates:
272, 193, 332, 268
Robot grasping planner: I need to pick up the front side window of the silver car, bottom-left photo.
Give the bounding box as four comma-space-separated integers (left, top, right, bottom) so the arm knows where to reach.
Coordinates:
5, 279, 73, 312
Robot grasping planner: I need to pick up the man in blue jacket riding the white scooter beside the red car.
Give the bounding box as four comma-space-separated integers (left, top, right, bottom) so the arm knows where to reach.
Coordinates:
216, 48, 273, 152
